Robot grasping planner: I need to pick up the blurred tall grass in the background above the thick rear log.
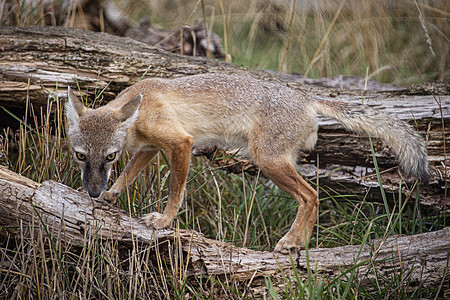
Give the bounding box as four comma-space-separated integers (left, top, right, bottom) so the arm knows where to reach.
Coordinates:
1, 0, 450, 86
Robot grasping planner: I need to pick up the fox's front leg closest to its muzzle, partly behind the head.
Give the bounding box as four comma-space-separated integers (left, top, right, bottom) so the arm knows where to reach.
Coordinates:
100, 150, 159, 203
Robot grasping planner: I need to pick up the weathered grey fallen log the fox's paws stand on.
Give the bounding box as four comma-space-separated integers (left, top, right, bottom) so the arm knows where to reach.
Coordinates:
0, 167, 450, 296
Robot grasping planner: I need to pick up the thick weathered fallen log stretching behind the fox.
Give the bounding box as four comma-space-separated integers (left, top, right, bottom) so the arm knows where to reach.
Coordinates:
0, 27, 450, 211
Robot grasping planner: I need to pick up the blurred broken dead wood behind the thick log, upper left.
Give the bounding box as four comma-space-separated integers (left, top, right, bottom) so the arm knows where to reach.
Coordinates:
2, 0, 225, 58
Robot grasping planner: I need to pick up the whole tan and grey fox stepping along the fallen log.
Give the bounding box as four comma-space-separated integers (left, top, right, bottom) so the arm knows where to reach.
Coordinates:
65, 73, 429, 254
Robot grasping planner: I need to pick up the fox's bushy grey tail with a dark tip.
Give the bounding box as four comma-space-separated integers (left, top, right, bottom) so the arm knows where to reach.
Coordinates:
314, 100, 429, 182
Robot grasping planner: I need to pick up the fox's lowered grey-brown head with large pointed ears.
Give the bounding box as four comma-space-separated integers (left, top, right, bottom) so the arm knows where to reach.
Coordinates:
65, 87, 142, 198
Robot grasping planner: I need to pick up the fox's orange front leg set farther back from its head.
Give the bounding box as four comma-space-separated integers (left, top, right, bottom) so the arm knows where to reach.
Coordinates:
142, 136, 193, 229
